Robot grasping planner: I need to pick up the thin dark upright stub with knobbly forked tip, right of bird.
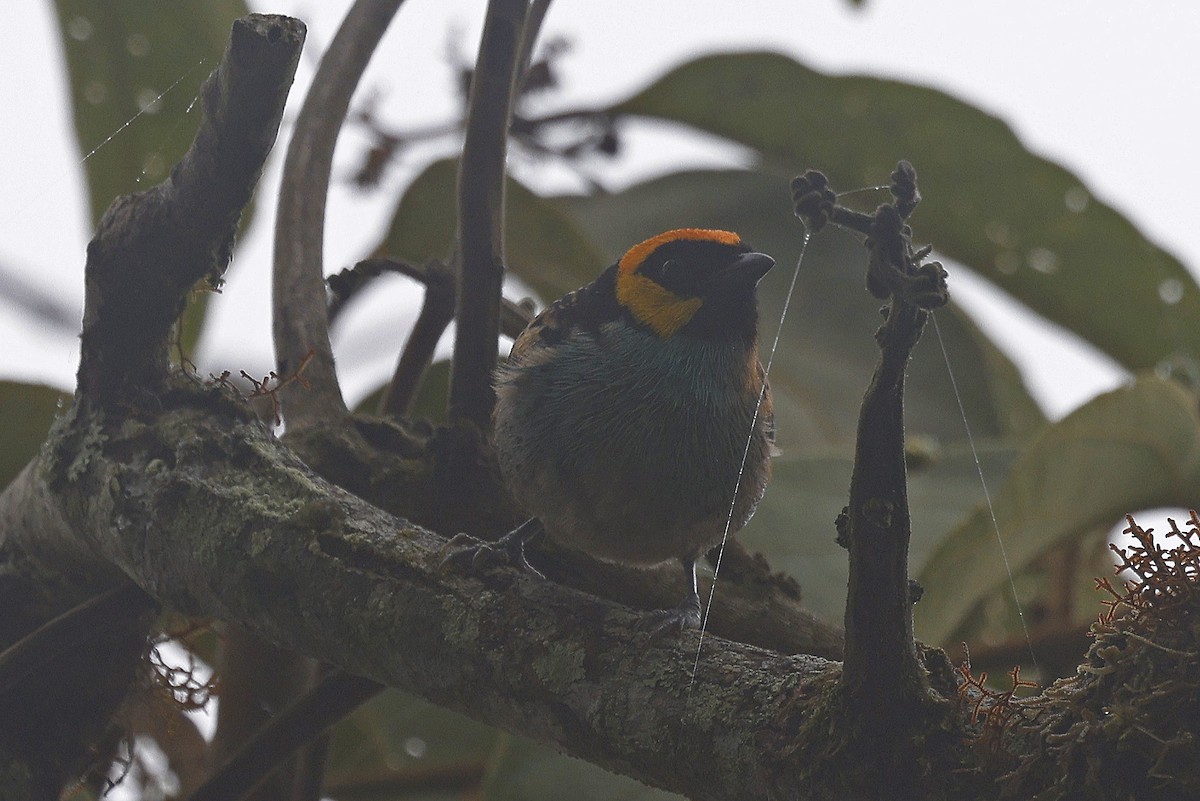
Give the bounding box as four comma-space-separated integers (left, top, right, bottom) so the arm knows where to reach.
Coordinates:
792, 162, 948, 787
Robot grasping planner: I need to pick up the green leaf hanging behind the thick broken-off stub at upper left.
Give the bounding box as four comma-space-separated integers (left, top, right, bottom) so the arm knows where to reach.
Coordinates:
54, 0, 252, 354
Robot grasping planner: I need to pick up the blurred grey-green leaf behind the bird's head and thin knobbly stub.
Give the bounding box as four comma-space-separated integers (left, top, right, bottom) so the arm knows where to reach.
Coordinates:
556, 171, 1044, 456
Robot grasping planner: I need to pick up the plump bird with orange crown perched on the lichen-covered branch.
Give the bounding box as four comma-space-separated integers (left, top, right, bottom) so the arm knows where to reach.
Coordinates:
448, 228, 775, 631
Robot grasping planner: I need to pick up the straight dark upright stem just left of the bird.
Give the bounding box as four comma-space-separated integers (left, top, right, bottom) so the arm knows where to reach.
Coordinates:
450, 0, 528, 430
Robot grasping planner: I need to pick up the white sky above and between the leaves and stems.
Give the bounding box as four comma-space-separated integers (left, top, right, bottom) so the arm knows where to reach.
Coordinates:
0, 0, 1200, 416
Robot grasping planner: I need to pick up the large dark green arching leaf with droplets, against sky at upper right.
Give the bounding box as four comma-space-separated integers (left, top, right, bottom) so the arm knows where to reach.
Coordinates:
611, 53, 1200, 369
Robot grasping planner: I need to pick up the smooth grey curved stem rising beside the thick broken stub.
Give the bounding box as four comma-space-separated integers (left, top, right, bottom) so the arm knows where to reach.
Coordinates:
272, 0, 403, 429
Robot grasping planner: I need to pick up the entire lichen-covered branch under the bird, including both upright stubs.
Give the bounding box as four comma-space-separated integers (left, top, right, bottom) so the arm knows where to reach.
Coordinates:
0, 4, 1200, 800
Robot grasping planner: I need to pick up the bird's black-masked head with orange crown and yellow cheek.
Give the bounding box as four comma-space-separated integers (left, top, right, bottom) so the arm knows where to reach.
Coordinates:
616, 228, 775, 342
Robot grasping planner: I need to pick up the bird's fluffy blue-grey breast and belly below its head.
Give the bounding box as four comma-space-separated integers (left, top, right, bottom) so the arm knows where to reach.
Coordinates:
496, 345, 769, 565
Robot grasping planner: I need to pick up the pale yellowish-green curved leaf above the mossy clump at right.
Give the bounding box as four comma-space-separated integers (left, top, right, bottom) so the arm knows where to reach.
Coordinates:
914, 377, 1200, 643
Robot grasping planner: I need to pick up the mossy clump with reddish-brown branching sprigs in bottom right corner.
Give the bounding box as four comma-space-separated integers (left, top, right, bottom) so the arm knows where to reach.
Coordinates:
998, 512, 1200, 800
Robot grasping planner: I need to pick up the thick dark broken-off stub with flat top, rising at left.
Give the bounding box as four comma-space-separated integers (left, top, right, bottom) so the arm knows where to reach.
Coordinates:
79, 14, 305, 403
